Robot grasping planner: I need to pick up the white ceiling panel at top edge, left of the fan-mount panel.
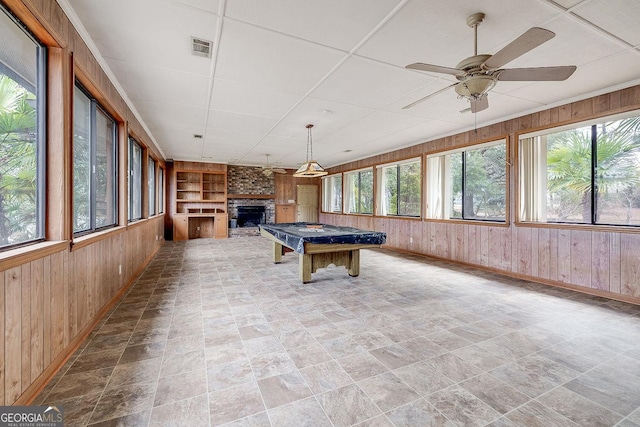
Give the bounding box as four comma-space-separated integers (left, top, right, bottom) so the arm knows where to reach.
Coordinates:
226, 0, 400, 51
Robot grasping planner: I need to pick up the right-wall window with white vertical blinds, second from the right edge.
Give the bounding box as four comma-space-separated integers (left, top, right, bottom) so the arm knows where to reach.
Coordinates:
427, 140, 507, 222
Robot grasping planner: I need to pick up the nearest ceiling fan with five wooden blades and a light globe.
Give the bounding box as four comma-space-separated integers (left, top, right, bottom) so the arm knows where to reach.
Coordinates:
402, 12, 577, 113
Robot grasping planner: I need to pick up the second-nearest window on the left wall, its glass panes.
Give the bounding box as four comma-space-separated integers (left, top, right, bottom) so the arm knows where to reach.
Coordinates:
73, 85, 118, 233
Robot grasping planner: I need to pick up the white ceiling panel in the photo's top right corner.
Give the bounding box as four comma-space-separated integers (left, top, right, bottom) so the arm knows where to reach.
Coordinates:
573, 0, 640, 46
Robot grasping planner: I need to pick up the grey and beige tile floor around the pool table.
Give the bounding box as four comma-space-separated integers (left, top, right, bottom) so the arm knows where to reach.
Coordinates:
34, 237, 640, 427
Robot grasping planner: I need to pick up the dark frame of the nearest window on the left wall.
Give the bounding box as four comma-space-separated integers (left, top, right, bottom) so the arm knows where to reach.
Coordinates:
0, 2, 49, 252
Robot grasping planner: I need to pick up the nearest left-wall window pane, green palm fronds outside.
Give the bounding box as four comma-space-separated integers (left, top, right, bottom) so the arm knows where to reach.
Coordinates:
0, 6, 46, 249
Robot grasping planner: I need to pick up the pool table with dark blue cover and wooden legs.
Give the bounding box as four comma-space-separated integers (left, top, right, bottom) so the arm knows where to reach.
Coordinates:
260, 222, 387, 283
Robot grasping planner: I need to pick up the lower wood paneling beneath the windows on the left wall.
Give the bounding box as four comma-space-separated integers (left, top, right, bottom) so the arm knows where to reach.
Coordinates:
0, 217, 163, 405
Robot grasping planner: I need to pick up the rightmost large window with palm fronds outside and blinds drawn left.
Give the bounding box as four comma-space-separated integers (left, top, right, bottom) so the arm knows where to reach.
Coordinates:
518, 112, 640, 225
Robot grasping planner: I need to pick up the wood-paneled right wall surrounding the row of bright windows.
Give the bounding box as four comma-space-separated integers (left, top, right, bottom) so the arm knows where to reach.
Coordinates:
320, 86, 640, 304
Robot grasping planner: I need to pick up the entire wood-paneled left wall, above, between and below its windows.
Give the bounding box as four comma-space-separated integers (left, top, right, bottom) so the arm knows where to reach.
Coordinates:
0, 0, 164, 405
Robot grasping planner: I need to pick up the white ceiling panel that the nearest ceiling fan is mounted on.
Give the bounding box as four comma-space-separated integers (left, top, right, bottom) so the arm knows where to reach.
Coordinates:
357, 0, 558, 67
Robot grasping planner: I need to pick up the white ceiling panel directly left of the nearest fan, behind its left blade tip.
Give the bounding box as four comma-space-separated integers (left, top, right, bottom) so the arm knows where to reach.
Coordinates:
311, 56, 435, 108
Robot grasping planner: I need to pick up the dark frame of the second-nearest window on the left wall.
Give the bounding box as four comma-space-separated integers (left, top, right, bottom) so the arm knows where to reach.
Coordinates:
72, 83, 120, 238
